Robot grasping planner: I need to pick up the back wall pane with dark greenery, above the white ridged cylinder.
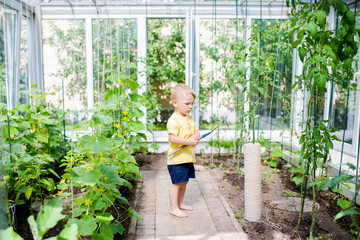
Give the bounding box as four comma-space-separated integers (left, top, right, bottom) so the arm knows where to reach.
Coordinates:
250, 19, 292, 130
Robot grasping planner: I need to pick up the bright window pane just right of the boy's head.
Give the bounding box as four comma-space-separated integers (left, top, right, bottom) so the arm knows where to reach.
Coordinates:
199, 19, 245, 129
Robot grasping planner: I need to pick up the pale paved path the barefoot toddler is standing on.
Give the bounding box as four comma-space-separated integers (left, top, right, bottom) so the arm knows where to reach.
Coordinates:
130, 164, 247, 240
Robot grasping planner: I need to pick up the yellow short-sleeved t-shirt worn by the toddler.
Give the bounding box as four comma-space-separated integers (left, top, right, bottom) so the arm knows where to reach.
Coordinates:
166, 113, 196, 165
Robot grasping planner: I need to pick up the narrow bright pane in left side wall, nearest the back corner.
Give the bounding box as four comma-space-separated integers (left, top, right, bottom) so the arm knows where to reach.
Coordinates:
19, 17, 29, 104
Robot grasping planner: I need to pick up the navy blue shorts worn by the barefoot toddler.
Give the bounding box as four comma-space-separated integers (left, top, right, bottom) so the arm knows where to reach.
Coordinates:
168, 163, 195, 184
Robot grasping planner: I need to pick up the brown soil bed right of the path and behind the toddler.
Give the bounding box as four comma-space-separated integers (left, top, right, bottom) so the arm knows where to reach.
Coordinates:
136, 154, 356, 240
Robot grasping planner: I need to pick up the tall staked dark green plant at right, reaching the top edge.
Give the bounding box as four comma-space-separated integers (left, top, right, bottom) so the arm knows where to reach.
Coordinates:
287, 0, 359, 239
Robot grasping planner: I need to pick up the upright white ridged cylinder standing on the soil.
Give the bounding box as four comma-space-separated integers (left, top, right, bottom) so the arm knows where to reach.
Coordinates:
244, 143, 262, 221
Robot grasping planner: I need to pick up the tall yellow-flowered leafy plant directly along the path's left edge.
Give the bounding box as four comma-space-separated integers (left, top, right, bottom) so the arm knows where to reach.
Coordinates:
54, 73, 148, 239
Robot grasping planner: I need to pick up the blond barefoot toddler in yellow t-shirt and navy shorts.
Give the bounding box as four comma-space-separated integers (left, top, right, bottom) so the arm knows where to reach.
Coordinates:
167, 84, 200, 218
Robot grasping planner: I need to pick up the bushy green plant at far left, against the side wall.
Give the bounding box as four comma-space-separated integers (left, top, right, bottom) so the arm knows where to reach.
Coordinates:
0, 85, 69, 227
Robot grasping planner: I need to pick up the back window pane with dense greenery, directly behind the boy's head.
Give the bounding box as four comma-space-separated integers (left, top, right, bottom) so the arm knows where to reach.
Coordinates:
147, 19, 186, 130
